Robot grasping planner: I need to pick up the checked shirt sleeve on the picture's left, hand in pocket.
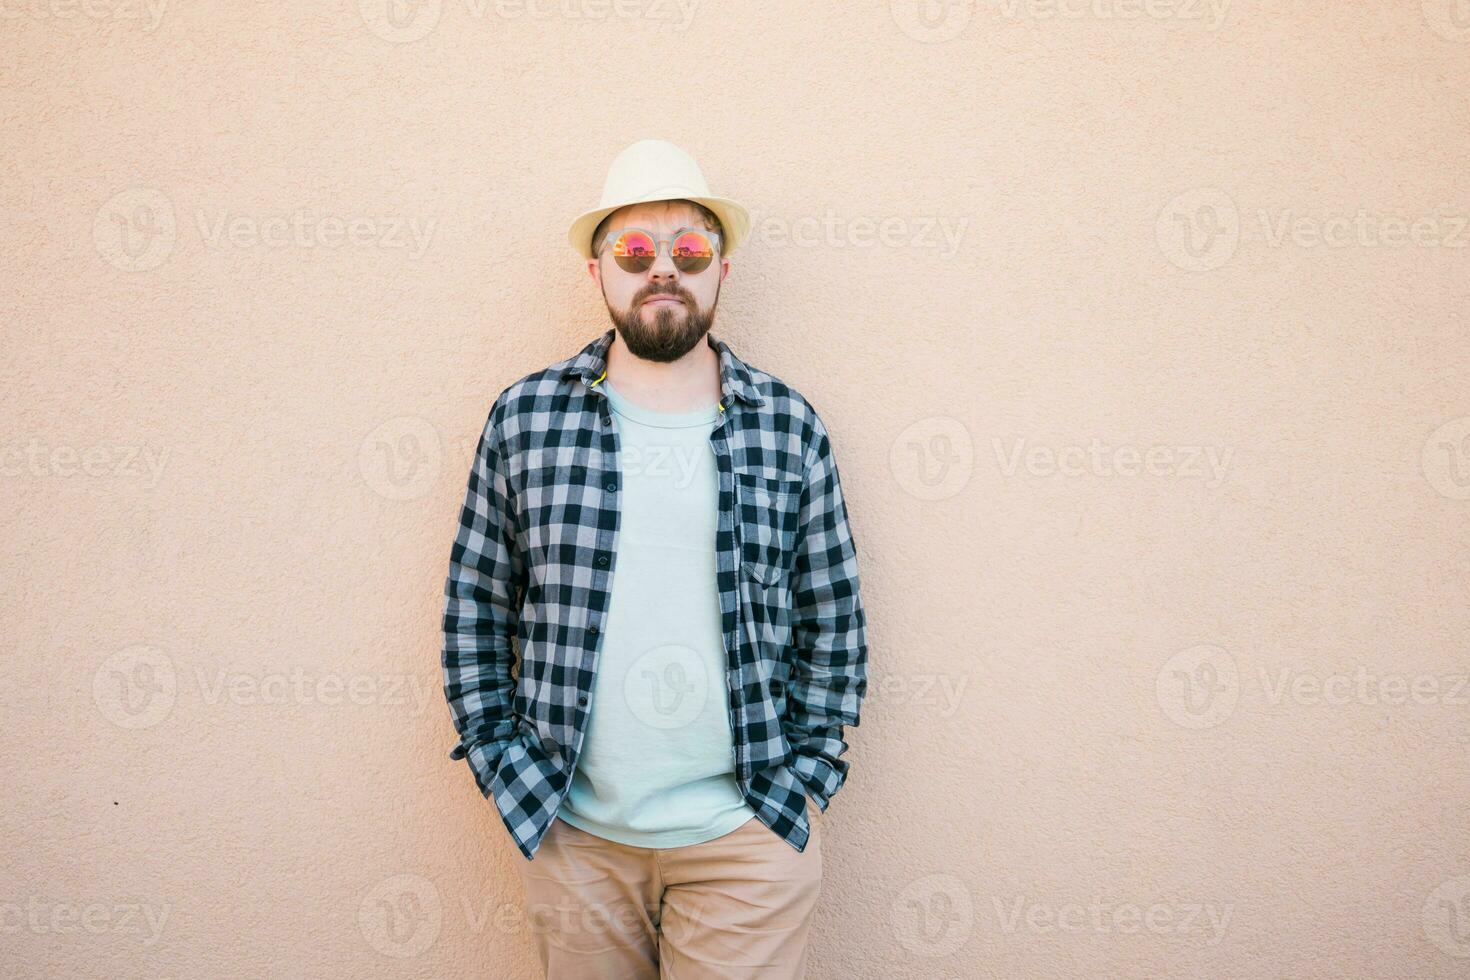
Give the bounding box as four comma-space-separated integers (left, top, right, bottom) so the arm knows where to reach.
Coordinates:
441, 400, 525, 798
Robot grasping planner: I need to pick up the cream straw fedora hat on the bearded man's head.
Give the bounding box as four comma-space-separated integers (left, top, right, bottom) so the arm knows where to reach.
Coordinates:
567, 140, 750, 259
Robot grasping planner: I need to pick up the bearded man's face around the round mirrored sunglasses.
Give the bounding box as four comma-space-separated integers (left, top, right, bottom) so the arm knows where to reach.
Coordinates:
587, 201, 731, 361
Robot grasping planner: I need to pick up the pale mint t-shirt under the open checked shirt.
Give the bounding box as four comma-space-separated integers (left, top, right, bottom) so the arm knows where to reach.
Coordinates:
557, 379, 756, 848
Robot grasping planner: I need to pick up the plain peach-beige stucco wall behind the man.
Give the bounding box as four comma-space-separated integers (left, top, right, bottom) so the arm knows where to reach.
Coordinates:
0, 0, 1470, 980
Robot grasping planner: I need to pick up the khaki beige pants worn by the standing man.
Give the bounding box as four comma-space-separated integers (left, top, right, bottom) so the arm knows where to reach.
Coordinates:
519, 799, 825, 980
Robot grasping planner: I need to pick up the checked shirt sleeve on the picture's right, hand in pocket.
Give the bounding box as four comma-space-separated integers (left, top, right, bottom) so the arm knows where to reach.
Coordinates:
785, 419, 867, 811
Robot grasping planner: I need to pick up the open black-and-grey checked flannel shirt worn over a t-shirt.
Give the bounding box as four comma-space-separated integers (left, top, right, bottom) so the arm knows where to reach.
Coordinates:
442, 329, 867, 860
